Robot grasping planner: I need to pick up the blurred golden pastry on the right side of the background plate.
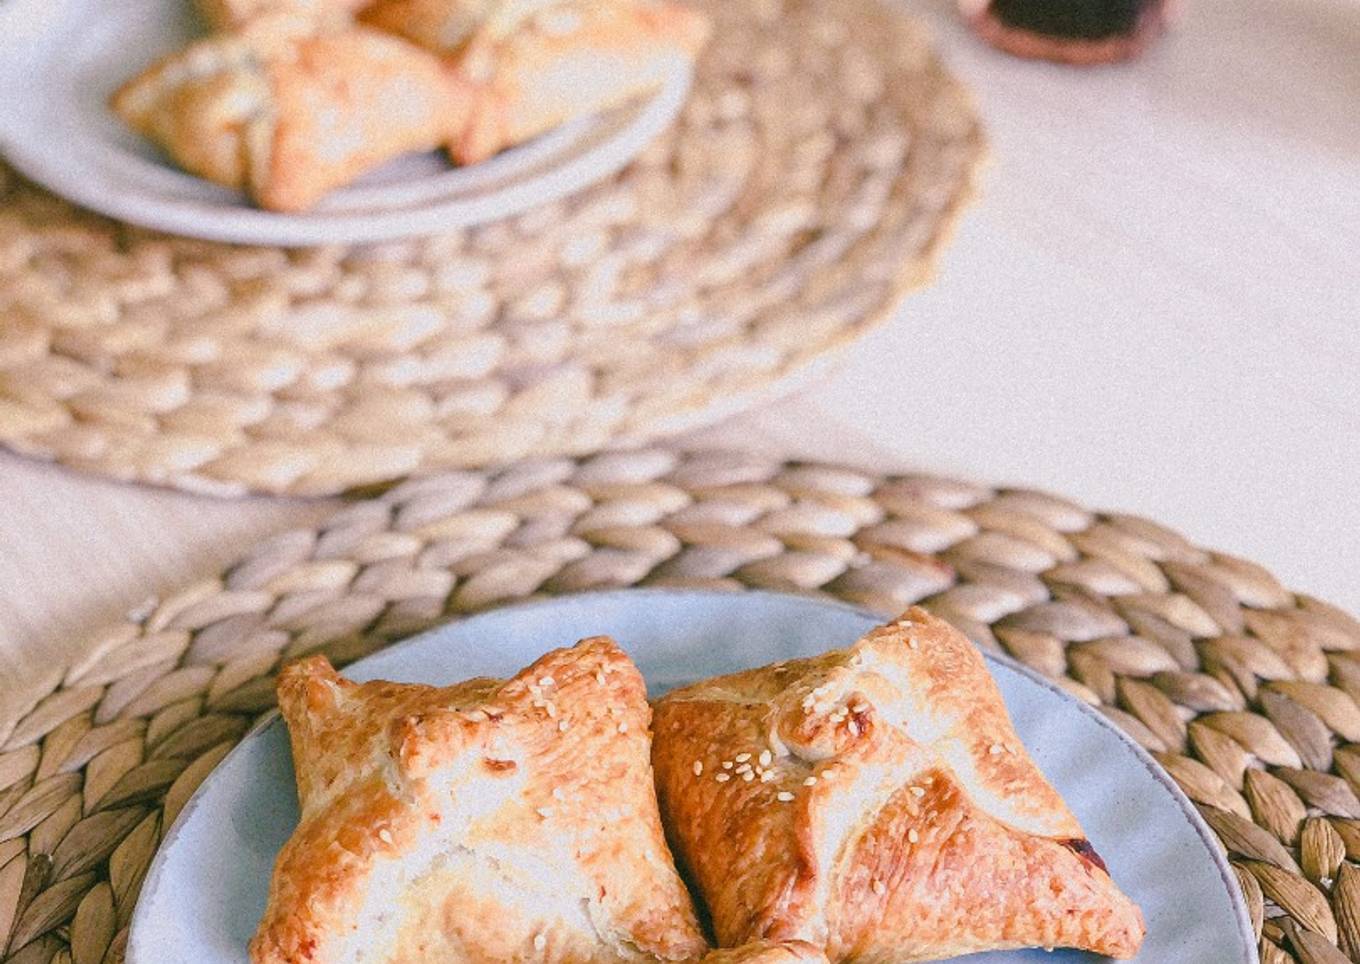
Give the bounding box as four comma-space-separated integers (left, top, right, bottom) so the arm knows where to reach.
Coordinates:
449, 0, 709, 165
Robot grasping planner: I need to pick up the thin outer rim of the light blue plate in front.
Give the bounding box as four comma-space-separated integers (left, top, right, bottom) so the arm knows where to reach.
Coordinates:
126, 586, 1258, 964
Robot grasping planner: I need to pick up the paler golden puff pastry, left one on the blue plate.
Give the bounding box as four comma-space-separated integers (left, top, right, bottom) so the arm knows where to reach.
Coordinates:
250, 638, 707, 964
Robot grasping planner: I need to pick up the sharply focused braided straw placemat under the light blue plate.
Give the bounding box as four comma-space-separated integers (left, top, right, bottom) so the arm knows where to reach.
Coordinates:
0, 450, 1360, 964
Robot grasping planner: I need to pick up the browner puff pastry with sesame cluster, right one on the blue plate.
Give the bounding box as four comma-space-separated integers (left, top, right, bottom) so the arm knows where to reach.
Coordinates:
653, 608, 1144, 961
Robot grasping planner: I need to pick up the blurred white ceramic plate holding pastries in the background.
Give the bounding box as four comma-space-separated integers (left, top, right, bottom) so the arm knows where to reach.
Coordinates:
0, 0, 691, 245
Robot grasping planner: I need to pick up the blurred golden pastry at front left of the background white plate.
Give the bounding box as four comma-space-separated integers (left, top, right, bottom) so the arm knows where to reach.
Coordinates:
113, 14, 468, 211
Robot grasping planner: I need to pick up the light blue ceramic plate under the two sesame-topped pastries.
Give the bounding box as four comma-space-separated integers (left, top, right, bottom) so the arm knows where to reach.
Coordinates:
128, 590, 1257, 964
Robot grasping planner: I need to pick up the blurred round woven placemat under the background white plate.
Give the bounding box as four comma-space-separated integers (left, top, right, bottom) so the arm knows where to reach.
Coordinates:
0, 0, 982, 494
